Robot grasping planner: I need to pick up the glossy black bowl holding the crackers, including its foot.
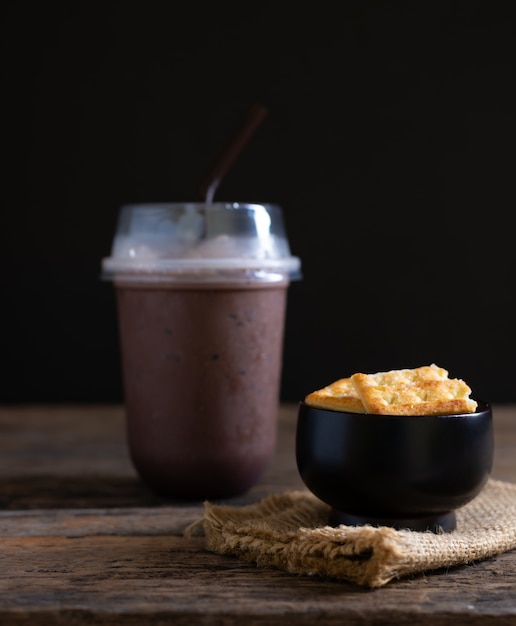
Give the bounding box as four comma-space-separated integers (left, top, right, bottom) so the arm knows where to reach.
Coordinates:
296, 402, 494, 532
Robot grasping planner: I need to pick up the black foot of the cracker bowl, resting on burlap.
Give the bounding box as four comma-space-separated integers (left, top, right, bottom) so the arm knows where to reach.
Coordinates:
328, 508, 457, 535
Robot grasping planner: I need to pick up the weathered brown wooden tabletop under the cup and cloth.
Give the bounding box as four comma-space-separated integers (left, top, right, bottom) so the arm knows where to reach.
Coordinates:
0, 405, 516, 626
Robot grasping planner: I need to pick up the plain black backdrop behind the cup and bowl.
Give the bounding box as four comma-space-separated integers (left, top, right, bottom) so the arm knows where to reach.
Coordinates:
0, 0, 516, 403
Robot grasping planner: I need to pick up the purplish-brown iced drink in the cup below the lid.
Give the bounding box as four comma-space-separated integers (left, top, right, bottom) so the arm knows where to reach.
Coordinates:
117, 283, 287, 498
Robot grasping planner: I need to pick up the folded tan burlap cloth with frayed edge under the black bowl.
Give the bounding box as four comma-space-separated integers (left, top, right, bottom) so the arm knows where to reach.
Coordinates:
185, 479, 516, 588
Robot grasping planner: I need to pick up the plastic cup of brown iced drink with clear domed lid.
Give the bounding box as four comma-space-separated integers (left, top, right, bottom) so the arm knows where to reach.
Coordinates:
102, 202, 300, 499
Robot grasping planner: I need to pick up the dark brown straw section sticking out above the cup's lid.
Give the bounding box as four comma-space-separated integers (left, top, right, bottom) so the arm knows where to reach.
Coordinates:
191, 104, 268, 204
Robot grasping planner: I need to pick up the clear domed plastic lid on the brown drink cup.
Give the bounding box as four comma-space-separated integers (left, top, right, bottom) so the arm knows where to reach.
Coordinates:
102, 202, 301, 282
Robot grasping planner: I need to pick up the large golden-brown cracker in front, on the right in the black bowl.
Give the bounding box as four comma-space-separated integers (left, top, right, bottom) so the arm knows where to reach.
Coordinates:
351, 366, 477, 415
